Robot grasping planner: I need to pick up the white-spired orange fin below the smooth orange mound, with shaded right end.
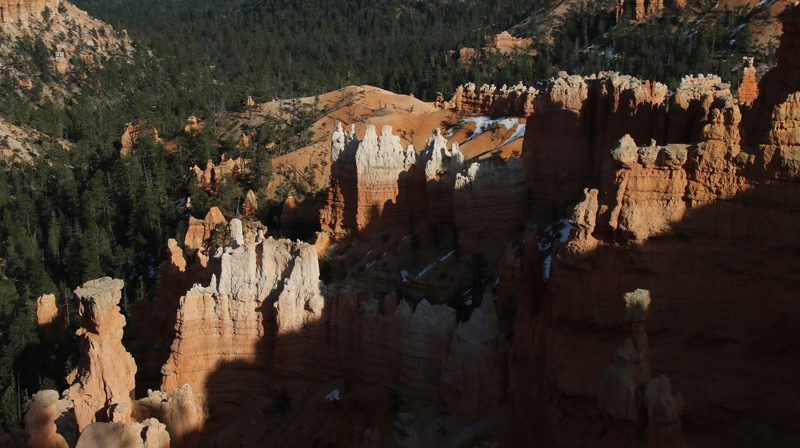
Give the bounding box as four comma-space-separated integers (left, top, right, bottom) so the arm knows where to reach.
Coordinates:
320, 125, 526, 247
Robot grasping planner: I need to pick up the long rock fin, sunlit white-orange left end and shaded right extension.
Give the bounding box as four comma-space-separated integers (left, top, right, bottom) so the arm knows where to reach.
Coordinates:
145, 220, 508, 437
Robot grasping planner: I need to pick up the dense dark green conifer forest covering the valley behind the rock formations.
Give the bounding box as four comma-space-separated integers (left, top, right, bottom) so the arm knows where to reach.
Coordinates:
0, 0, 772, 427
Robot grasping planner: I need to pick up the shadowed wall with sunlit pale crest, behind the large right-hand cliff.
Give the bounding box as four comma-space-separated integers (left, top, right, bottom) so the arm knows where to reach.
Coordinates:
522, 72, 752, 214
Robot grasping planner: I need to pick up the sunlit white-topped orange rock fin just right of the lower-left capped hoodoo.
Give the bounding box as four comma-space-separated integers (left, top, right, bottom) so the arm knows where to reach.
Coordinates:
161, 220, 323, 411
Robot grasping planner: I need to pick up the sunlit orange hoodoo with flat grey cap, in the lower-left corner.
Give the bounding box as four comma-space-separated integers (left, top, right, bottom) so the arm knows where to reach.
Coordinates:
67, 277, 136, 432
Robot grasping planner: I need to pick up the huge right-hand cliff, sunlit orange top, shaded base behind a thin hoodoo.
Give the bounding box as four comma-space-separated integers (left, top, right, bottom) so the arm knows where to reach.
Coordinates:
512, 79, 800, 446
